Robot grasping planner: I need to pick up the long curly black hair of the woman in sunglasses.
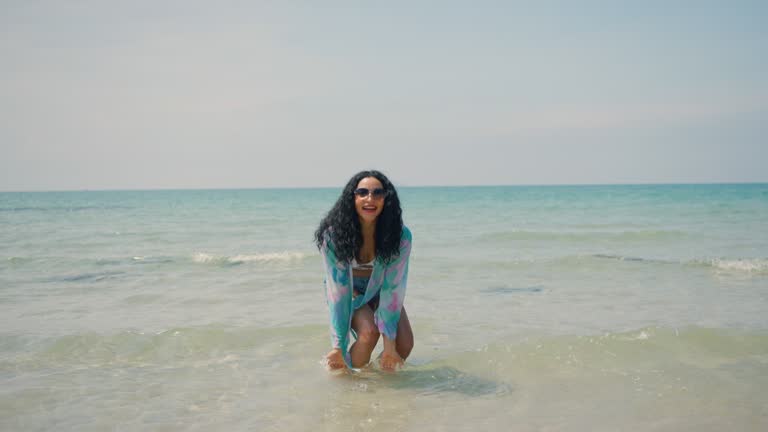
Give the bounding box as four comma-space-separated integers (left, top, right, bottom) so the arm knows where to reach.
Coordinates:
315, 170, 403, 263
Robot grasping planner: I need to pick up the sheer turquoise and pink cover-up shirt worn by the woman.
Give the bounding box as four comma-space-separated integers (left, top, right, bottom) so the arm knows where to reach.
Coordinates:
320, 226, 413, 368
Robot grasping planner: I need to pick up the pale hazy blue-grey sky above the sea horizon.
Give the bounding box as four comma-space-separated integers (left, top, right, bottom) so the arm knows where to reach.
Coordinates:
0, 0, 768, 191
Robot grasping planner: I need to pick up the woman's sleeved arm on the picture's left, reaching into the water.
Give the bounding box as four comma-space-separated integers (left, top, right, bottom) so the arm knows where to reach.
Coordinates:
320, 235, 352, 367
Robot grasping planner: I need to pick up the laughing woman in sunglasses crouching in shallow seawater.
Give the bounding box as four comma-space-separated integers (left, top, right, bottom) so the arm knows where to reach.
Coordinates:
315, 171, 413, 371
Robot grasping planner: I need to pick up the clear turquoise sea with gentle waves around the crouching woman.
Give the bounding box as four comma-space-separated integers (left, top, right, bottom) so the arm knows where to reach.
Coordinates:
0, 184, 768, 431
